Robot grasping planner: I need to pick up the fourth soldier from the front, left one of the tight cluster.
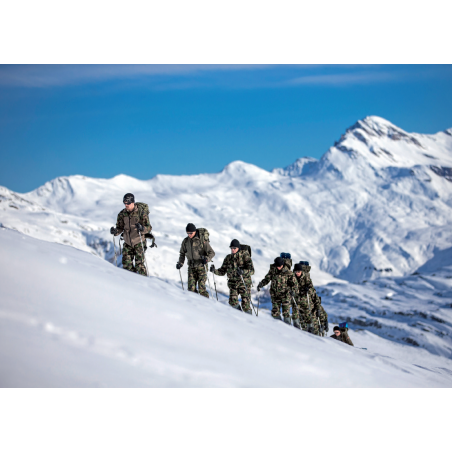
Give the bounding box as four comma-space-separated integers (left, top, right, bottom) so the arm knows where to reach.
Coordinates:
257, 257, 298, 325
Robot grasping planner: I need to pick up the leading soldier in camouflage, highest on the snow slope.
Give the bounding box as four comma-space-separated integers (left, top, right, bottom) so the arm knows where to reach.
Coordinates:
110, 193, 152, 276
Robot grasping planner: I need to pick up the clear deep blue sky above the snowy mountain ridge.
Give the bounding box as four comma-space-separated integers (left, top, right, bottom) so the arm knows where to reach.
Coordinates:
0, 65, 452, 192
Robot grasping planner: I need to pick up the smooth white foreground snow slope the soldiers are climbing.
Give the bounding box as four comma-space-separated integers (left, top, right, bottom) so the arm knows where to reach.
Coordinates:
0, 228, 452, 387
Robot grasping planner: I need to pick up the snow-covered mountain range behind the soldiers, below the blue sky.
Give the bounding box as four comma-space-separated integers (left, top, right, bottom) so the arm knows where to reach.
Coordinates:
0, 116, 452, 382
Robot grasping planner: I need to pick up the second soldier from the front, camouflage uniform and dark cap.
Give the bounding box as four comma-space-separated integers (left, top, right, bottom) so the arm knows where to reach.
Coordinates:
176, 223, 215, 298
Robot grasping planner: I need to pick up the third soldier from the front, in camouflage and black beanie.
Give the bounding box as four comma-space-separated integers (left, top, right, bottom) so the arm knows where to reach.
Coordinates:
210, 239, 254, 314
